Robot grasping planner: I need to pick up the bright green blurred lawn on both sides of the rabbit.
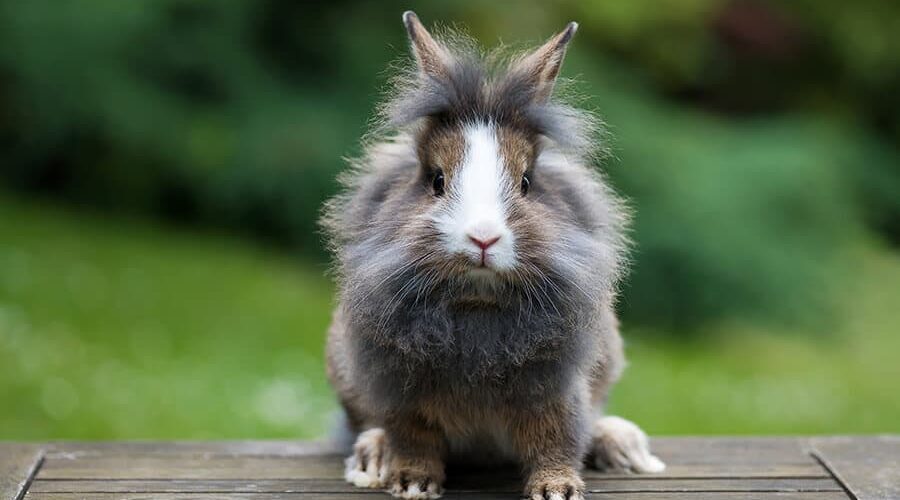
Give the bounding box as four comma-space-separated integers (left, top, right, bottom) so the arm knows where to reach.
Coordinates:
0, 197, 900, 439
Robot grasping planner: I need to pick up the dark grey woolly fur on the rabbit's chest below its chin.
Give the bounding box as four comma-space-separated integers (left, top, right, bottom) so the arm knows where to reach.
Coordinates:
356, 300, 590, 410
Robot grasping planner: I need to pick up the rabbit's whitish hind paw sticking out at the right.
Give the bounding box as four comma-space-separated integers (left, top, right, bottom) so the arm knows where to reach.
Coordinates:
592, 417, 666, 474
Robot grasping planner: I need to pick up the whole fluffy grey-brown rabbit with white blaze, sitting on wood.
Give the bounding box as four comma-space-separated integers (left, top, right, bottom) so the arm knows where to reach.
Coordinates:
322, 12, 665, 500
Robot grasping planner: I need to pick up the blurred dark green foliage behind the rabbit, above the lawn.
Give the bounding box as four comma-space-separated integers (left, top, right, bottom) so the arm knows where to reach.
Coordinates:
0, 0, 900, 331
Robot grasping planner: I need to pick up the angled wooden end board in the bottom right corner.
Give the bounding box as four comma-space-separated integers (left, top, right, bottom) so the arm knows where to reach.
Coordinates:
810, 436, 900, 500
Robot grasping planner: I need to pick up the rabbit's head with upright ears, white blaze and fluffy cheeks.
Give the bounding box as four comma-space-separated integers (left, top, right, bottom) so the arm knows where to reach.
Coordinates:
326, 12, 625, 307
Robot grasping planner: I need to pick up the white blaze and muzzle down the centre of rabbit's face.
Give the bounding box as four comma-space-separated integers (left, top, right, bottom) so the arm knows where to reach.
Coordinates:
437, 124, 516, 270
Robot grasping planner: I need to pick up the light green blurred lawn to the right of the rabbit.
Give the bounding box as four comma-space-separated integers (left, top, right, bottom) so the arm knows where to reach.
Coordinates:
612, 244, 900, 434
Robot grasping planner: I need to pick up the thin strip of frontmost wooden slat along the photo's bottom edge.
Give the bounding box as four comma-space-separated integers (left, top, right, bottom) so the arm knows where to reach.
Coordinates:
19, 492, 847, 500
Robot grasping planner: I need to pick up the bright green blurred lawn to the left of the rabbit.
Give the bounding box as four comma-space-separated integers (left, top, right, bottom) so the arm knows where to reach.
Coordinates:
0, 194, 335, 439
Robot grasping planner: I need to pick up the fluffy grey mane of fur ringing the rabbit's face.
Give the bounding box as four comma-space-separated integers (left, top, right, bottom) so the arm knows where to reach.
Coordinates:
322, 29, 628, 376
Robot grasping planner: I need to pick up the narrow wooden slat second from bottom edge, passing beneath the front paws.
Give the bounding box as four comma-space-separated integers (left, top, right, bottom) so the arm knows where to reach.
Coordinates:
30, 478, 842, 493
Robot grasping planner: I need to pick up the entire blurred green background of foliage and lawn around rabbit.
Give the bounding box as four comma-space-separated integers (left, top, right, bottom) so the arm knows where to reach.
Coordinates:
0, 0, 900, 439
